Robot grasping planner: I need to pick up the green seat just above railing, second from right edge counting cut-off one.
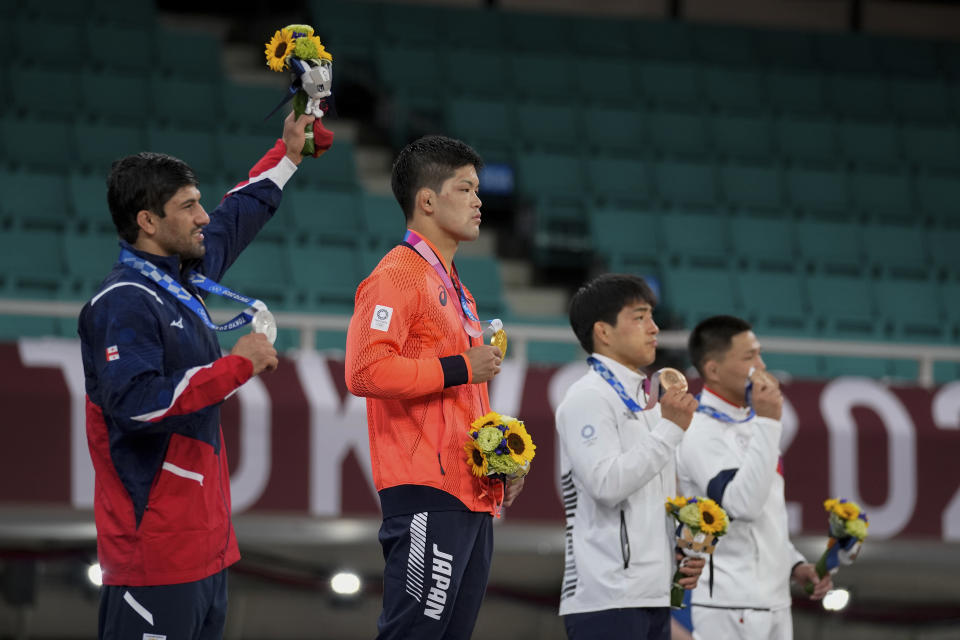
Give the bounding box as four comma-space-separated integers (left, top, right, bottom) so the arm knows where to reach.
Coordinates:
873, 278, 952, 342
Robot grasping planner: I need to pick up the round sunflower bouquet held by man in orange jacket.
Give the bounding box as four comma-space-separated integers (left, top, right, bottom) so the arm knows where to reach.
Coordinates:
464, 411, 537, 479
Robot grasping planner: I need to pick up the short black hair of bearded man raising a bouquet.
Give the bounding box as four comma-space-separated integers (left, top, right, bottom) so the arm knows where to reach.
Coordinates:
107, 151, 199, 244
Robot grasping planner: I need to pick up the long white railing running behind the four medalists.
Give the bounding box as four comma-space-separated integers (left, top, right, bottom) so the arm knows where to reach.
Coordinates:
0, 298, 960, 388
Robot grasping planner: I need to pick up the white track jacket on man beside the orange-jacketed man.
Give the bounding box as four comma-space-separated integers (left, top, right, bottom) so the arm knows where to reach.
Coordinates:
556, 354, 683, 615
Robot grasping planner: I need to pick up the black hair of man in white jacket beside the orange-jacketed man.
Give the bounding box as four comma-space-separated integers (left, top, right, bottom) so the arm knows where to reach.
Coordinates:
570, 273, 657, 353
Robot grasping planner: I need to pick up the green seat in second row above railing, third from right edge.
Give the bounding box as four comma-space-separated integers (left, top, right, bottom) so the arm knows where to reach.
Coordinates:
796, 220, 864, 275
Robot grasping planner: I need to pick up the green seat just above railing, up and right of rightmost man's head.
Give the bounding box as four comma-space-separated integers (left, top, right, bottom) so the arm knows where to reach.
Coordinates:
736, 271, 814, 335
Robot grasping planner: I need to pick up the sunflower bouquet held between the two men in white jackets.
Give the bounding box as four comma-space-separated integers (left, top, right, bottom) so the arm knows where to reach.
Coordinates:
664, 496, 730, 609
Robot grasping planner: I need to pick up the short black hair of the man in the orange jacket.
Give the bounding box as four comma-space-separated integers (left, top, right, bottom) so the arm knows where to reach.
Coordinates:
390, 136, 483, 221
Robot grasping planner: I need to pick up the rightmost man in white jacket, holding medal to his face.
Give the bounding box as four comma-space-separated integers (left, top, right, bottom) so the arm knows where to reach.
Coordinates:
678, 316, 832, 640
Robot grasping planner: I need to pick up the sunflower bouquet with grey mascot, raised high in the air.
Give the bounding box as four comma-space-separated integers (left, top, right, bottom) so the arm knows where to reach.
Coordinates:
264, 24, 333, 157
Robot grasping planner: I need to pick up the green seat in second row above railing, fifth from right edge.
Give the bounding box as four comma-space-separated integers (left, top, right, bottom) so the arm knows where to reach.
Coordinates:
660, 213, 730, 267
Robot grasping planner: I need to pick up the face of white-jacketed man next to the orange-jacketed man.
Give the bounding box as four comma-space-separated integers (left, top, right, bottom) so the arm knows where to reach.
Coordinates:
594, 300, 660, 370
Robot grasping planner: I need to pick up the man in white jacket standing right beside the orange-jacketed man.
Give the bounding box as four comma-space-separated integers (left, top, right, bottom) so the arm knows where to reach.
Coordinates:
556, 274, 703, 640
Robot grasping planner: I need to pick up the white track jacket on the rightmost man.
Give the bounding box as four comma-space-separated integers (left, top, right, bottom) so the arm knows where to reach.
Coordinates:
677, 389, 804, 610
